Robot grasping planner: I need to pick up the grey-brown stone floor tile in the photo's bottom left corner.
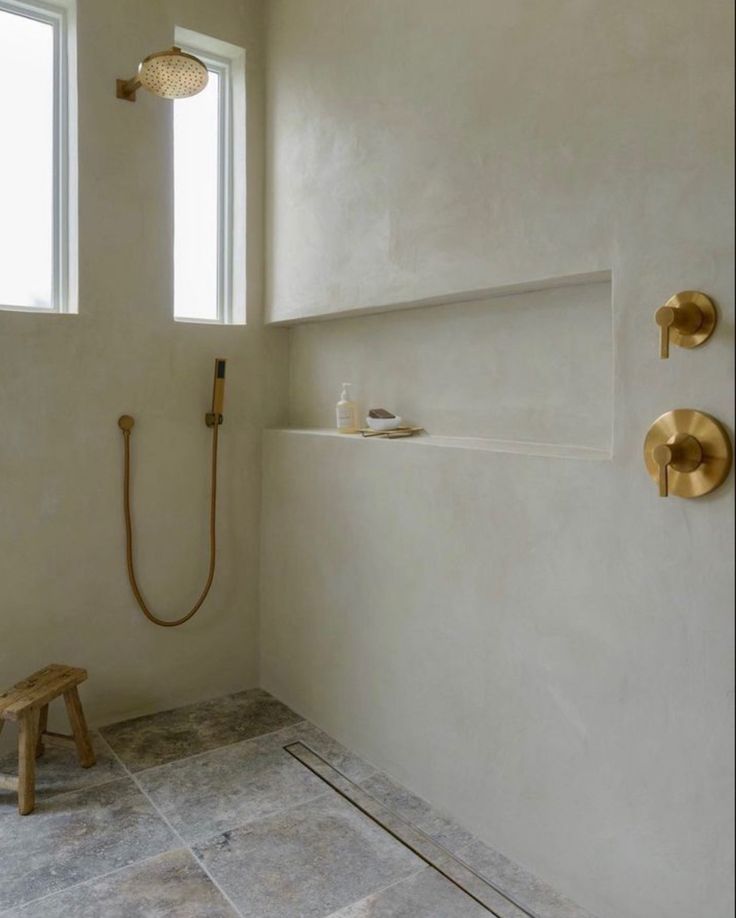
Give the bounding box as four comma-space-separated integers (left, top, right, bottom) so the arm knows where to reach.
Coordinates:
3, 849, 237, 918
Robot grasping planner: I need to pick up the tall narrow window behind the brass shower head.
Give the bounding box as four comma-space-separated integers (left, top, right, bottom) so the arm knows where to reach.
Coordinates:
174, 30, 245, 324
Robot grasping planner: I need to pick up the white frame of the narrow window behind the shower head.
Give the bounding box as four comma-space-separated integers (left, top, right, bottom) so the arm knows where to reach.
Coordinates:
174, 28, 245, 325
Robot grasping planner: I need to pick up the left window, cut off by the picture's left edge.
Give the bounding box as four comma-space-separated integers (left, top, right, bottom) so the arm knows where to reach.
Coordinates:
0, 0, 75, 312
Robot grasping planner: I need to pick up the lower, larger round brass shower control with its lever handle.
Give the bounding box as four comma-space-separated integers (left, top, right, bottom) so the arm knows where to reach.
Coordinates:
644, 408, 732, 497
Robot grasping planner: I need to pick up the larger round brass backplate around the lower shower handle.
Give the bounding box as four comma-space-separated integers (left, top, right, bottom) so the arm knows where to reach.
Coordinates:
644, 408, 733, 497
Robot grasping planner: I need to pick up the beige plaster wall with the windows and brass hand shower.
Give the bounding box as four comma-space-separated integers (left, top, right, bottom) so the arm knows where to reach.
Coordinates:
0, 0, 286, 741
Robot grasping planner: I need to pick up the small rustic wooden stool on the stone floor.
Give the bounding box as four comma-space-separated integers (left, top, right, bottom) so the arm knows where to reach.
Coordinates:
0, 663, 96, 816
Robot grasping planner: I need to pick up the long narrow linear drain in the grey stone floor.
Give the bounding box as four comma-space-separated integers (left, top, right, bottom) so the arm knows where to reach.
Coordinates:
284, 743, 535, 918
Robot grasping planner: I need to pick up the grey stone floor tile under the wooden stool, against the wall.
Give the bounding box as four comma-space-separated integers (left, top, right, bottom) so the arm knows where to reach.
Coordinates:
0, 733, 125, 818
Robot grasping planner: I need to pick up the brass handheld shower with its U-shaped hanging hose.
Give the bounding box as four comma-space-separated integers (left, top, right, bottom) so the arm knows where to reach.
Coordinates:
118, 358, 225, 628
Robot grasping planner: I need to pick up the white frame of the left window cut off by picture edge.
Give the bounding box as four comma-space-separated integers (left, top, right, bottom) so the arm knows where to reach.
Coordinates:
0, 0, 77, 314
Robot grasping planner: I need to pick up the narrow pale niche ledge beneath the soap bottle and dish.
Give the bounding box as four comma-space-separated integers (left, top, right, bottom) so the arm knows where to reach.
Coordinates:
267, 427, 613, 462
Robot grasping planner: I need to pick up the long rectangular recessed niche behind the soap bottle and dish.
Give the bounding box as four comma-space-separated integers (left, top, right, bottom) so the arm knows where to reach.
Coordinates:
289, 275, 613, 453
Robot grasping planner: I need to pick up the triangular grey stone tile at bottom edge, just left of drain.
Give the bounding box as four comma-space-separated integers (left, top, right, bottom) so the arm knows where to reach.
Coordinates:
331, 867, 490, 918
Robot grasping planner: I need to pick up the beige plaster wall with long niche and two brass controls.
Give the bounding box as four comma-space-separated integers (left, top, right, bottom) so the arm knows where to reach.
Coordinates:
261, 0, 734, 918
